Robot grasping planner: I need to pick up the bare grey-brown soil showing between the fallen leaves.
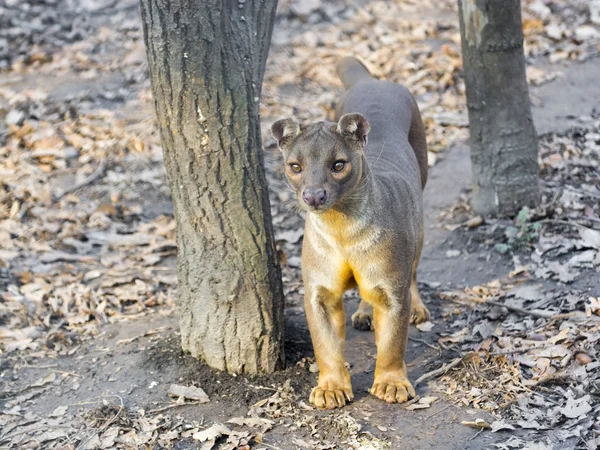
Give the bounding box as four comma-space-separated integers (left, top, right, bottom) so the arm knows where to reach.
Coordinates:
0, 3, 600, 450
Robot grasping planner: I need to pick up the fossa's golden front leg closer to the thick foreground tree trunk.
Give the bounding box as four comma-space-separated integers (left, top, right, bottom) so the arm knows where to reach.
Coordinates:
305, 286, 353, 409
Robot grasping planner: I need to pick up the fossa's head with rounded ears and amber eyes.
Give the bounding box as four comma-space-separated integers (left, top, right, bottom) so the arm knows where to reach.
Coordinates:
271, 113, 369, 213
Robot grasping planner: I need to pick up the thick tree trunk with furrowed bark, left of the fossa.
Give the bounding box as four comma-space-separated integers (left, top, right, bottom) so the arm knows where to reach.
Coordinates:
141, 0, 283, 373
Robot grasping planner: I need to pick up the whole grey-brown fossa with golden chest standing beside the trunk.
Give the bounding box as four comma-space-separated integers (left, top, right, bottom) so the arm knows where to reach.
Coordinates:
272, 58, 429, 409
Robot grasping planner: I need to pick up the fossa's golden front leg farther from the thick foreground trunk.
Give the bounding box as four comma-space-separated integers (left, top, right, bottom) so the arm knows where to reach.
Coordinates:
369, 287, 415, 403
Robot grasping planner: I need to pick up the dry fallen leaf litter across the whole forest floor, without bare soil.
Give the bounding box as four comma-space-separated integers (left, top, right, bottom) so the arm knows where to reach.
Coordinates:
0, 0, 600, 449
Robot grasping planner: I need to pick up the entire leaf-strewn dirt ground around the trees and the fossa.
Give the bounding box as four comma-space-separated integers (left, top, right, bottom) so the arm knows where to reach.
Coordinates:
0, 0, 600, 450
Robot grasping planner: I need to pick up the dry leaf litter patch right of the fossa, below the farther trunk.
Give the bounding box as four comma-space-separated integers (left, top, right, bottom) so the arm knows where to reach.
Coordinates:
433, 123, 600, 448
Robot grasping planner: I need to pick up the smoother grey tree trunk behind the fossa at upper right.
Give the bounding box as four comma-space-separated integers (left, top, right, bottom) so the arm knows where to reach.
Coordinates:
459, 0, 539, 216
